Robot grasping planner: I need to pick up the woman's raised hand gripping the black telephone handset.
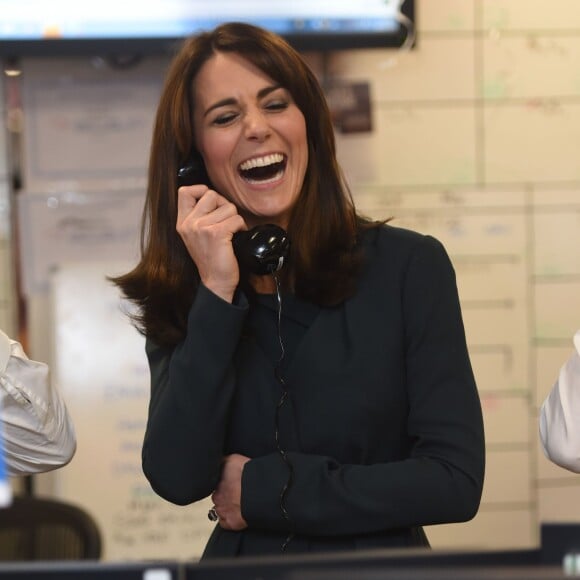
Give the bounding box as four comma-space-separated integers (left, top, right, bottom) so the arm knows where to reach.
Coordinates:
176, 185, 246, 302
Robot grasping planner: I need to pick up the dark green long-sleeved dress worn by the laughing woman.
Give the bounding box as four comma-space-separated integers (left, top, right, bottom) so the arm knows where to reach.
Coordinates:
143, 226, 485, 558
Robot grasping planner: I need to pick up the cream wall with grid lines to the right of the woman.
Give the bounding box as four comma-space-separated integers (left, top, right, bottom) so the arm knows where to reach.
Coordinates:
0, 0, 580, 560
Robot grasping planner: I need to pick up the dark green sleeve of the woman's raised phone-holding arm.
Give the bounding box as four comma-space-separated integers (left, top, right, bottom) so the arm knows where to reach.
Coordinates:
142, 285, 248, 505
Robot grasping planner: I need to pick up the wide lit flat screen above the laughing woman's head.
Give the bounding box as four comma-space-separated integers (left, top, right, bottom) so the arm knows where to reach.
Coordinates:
0, 0, 415, 58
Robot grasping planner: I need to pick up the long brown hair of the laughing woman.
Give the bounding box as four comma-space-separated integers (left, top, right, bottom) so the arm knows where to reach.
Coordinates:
111, 22, 370, 346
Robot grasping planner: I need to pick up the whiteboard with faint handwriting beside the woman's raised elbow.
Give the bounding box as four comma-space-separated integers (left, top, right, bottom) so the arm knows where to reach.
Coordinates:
50, 262, 213, 561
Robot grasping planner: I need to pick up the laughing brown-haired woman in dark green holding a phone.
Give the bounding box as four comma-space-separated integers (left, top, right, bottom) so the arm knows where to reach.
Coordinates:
114, 23, 485, 558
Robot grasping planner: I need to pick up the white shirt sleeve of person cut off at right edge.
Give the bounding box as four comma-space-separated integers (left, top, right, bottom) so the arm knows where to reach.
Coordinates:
540, 330, 580, 473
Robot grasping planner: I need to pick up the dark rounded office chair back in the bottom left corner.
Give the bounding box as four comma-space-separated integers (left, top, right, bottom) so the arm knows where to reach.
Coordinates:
0, 496, 102, 562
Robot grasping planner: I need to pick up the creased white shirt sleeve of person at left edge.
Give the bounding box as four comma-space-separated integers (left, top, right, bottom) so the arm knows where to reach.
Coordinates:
0, 330, 76, 476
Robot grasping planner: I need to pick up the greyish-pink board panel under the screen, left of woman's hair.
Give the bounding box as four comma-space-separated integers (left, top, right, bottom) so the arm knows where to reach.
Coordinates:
22, 58, 167, 191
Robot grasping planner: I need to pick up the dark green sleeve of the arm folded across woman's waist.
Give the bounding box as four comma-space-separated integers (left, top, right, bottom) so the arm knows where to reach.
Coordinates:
242, 237, 485, 535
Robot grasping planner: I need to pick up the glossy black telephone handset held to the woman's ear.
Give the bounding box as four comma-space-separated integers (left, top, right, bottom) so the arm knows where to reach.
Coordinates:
177, 160, 290, 276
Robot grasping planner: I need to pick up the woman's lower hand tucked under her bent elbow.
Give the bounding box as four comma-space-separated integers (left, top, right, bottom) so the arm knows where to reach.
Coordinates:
211, 453, 250, 531
